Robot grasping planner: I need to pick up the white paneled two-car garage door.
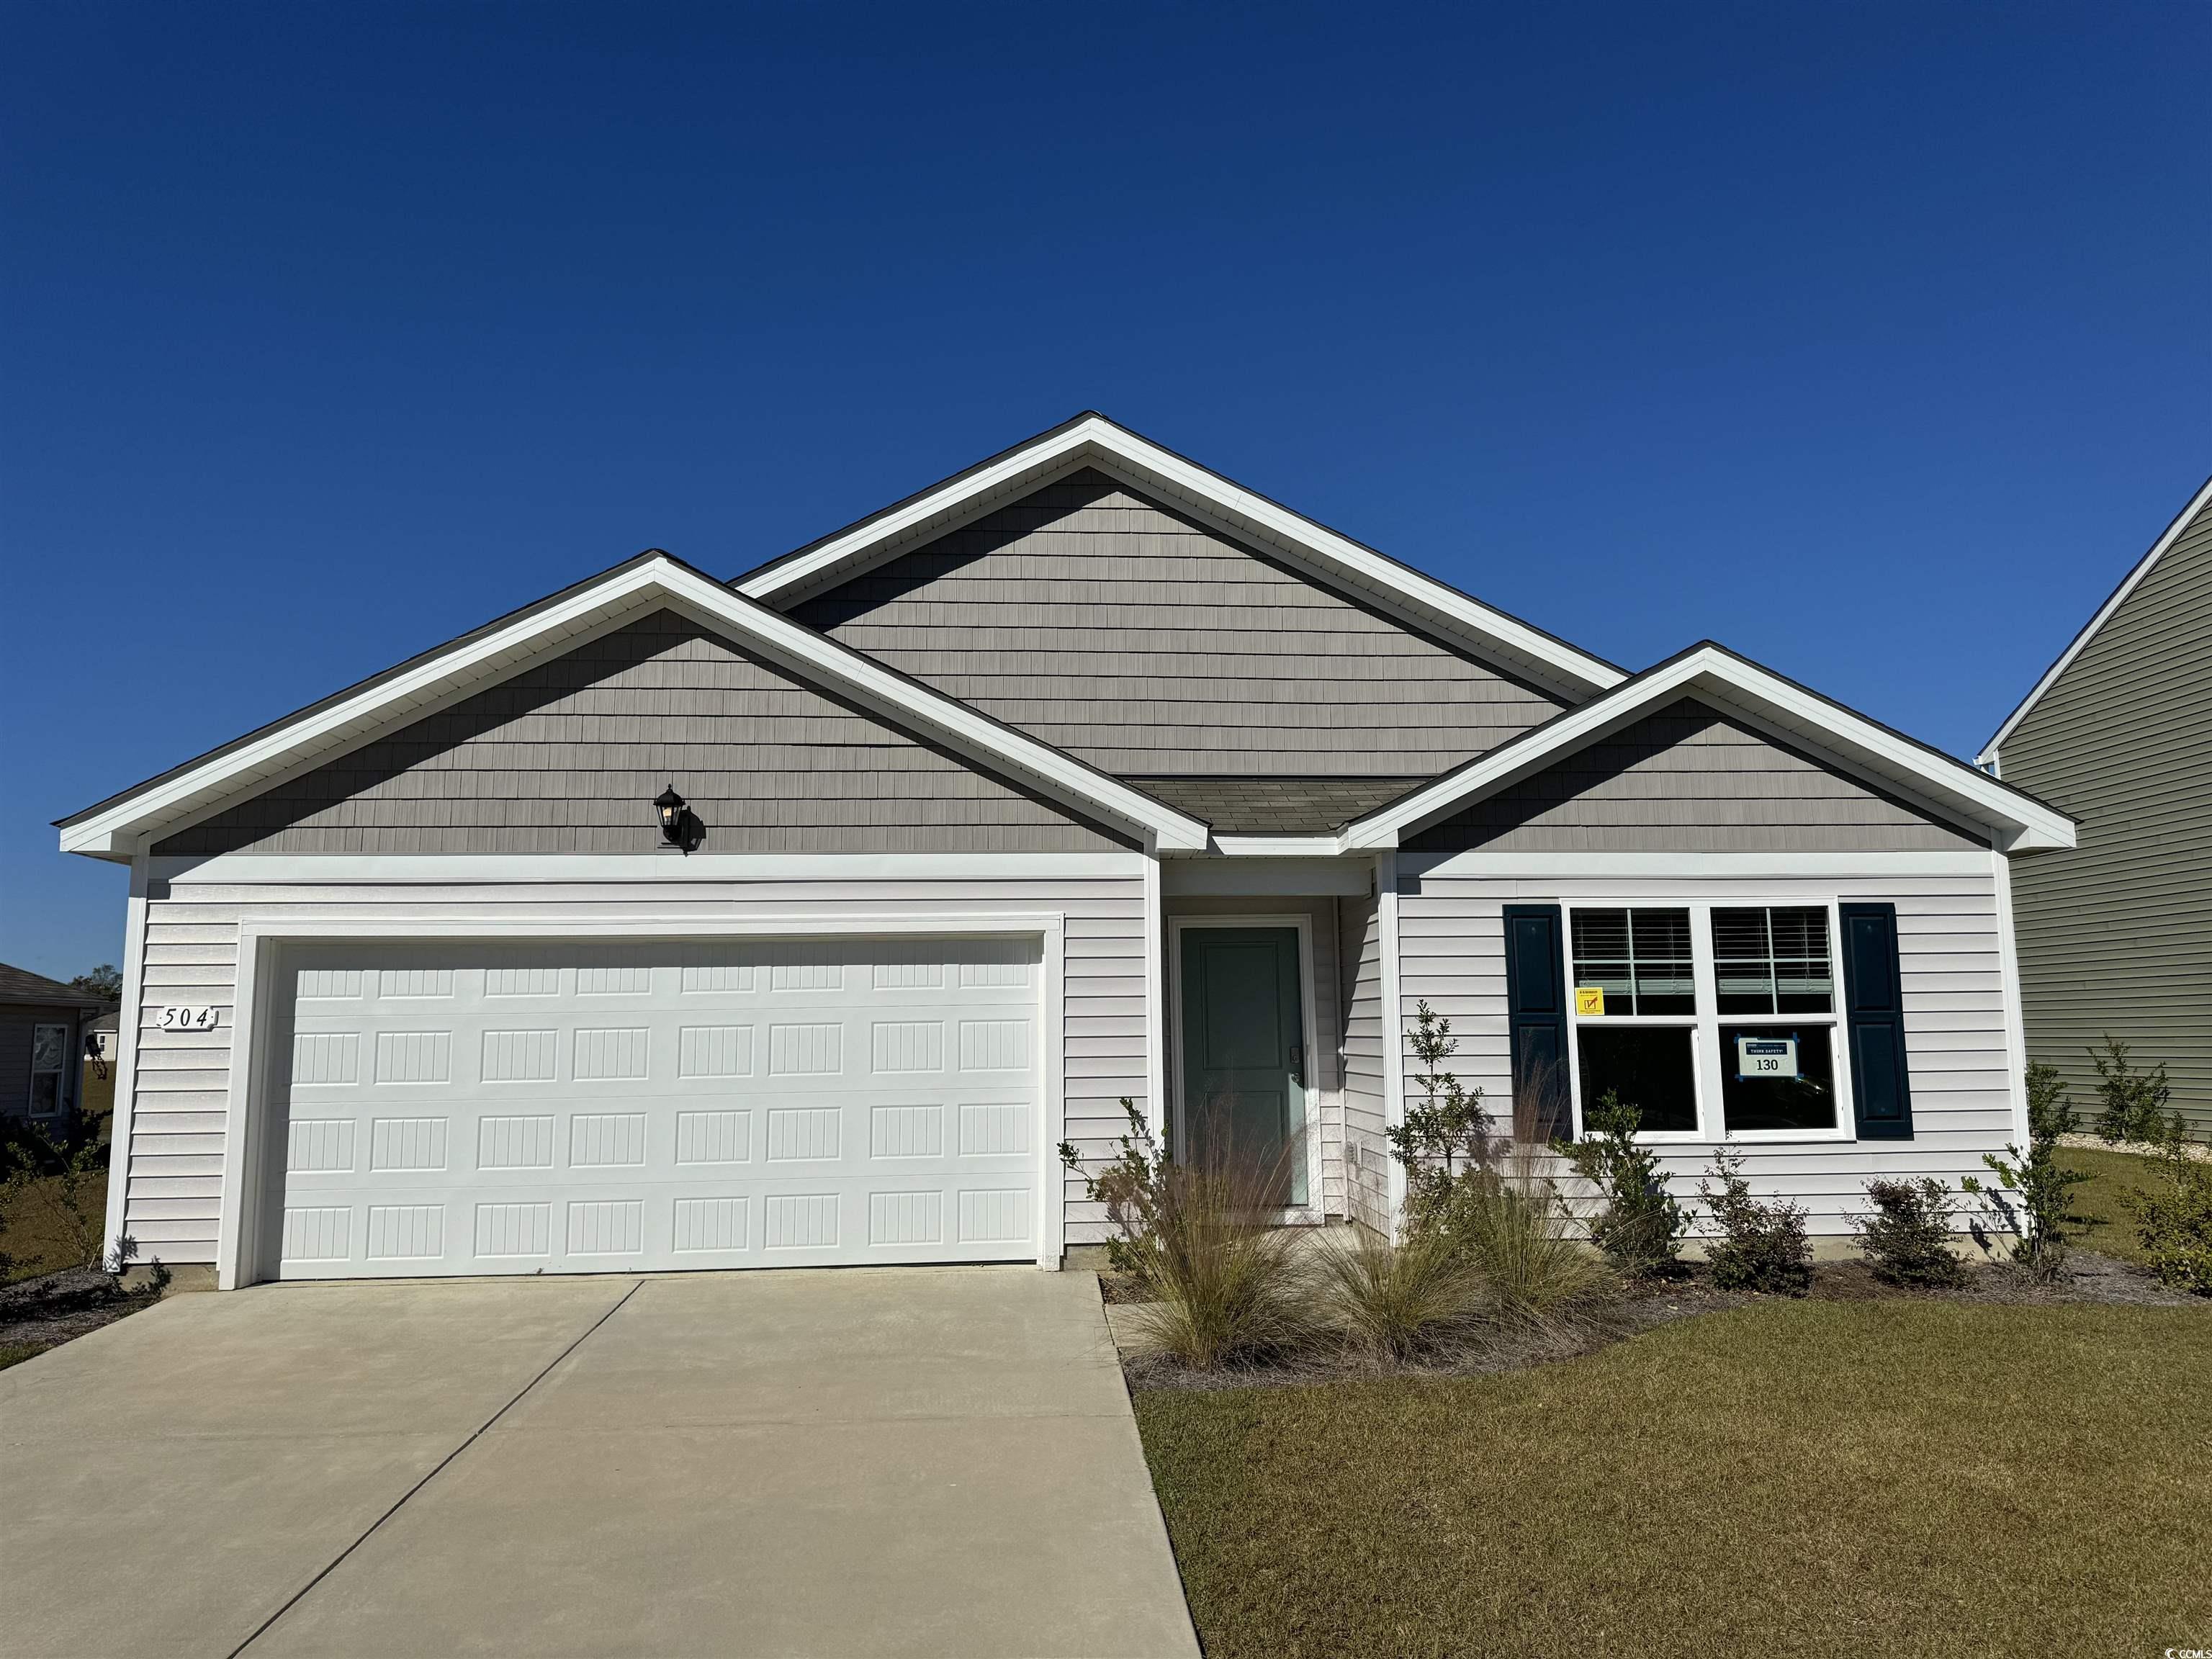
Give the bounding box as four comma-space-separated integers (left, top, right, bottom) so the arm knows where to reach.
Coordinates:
261, 938, 1042, 1279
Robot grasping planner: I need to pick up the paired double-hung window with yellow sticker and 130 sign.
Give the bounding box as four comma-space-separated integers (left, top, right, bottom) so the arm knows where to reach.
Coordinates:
1568, 904, 1851, 1141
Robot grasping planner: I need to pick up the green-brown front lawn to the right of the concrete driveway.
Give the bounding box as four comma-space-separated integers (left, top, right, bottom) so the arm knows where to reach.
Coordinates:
1137, 1300, 2212, 1659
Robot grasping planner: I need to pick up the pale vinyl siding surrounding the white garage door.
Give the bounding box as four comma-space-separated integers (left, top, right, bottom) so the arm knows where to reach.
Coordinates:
122, 869, 1146, 1265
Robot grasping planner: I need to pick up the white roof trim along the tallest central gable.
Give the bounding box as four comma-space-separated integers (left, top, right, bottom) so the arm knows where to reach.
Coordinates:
737, 413, 1626, 697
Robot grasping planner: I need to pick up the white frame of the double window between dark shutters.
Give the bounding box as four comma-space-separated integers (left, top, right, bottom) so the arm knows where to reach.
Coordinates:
1560, 891, 1858, 1146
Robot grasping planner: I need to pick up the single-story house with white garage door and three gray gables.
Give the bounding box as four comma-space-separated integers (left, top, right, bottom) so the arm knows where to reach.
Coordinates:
60, 413, 2072, 1285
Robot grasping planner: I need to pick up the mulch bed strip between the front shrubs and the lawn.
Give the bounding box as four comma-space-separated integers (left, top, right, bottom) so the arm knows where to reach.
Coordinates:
1100, 1250, 2212, 1389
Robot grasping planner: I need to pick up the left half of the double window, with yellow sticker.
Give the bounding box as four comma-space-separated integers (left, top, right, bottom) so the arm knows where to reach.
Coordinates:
1573, 909, 1699, 1135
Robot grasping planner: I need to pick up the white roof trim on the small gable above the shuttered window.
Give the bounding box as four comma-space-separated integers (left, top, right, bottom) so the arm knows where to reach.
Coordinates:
1341, 646, 2075, 852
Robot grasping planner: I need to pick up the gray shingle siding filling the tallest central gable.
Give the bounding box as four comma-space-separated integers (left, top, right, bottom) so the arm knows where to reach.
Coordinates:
792, 469, 1562, 776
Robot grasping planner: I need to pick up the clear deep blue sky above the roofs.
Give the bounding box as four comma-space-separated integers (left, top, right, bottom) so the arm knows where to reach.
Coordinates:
0, 0, 2212, 976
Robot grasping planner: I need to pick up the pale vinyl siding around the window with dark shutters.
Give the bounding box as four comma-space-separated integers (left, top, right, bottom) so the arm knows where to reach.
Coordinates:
1398, 871, 2015, 1234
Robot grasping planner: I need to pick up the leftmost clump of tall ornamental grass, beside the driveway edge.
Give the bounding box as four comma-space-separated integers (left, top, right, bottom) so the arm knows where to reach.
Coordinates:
1059, 1100, 1323, 1370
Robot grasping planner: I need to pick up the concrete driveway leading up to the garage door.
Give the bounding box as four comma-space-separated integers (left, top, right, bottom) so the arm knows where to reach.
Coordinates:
0, 1267, 1197, 1659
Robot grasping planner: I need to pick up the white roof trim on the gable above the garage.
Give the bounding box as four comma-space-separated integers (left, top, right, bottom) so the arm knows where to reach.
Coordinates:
62, 555, 1205, 858
